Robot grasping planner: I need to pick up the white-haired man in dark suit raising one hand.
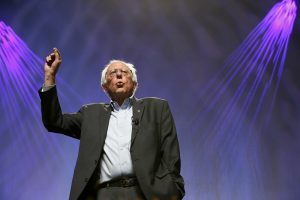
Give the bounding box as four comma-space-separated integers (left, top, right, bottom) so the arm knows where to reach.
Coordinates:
39, 48, 184, 200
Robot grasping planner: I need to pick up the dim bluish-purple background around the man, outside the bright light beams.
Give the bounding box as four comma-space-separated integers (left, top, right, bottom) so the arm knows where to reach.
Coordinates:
0, 0, 300, 200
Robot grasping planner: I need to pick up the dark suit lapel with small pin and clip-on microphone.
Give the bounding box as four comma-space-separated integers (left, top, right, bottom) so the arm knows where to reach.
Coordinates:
131, 97, 144, 147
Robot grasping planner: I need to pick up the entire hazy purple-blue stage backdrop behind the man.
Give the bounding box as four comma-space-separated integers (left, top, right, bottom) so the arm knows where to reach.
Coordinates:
0, 0, 300, 200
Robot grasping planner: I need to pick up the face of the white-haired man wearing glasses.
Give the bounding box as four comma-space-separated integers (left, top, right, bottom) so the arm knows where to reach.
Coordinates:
103, 62, 136, 100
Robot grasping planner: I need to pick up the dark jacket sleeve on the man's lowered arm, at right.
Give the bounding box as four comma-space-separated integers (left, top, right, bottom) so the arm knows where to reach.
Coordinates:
161, 102, 185, 198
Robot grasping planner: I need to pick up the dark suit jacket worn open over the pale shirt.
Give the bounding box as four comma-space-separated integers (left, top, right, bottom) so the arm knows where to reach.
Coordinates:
39, 87, 184, 200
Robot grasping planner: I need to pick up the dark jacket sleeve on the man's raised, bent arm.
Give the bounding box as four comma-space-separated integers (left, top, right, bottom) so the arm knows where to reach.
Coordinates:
39, 86, 82, 139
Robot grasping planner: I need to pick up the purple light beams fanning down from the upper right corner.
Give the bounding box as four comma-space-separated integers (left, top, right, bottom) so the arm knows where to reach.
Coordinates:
205, 0, 297, 132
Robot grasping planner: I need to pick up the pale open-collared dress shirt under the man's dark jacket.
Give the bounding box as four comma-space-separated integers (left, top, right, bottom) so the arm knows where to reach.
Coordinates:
100, 98, 134, 183
